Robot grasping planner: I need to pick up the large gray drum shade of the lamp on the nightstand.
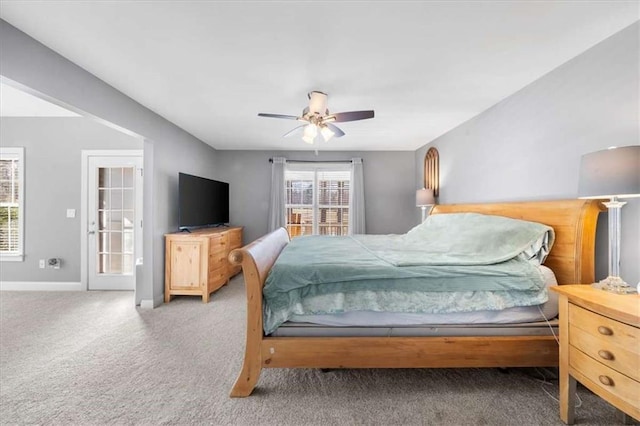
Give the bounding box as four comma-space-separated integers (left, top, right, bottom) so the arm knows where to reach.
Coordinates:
578, 145, 640, 198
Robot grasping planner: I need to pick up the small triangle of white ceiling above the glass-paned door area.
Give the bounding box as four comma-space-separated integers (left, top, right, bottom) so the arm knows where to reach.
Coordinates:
0, 82, 78, 117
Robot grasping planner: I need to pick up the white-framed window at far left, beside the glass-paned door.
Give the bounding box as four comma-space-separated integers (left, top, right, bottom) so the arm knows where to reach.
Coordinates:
0, 148, 24, 261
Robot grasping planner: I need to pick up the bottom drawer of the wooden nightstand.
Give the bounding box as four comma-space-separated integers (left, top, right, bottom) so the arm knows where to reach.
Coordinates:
569, 347, 640, 410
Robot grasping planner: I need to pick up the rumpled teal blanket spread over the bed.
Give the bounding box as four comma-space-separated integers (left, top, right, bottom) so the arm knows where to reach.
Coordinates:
263, 213, 553, 334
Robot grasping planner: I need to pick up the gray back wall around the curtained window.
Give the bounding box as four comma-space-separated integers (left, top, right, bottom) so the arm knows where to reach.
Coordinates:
216, 151, 418, 243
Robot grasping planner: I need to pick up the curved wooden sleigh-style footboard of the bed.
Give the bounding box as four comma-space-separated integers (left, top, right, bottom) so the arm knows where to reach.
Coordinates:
229, 228, 289, 397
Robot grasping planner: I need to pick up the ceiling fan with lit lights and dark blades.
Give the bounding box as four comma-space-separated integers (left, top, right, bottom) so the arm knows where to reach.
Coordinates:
258, 90, 374, 144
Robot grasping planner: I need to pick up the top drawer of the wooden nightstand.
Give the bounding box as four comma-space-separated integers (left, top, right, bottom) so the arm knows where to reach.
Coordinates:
569, 304, 640, 354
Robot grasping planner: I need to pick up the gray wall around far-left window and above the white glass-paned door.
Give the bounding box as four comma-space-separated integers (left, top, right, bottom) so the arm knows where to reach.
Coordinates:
0, 117, 142, 282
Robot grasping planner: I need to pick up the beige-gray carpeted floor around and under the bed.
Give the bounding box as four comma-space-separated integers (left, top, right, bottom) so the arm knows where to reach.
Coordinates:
0, 275, 632, 425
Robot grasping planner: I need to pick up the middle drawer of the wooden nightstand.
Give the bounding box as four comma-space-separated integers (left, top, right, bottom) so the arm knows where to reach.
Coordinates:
569, 324, 640, 381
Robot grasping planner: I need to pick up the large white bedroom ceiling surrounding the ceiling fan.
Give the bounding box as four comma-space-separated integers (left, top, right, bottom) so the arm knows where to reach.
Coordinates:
0, 0, 640, 150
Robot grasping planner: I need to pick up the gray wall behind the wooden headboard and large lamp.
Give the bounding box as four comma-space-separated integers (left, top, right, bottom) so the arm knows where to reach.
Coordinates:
415, 23, 640, 284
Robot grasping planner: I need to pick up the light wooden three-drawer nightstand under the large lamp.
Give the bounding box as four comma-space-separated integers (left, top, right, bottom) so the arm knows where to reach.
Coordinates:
553, 285, 640, 424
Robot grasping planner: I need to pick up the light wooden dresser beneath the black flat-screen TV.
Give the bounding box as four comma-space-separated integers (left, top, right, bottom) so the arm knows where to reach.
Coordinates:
164, 227, 242, 303
